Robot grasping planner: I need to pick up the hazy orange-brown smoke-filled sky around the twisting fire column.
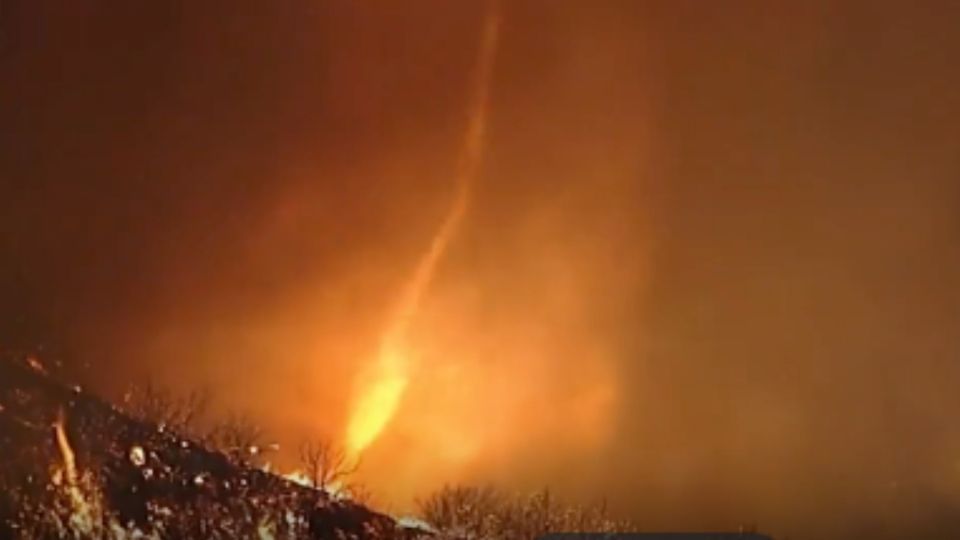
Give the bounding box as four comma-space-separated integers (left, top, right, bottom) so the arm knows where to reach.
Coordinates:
0, 0, 960, 537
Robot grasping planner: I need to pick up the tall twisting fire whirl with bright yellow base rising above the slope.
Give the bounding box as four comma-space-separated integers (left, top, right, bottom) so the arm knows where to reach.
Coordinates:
346, 9, 499, 457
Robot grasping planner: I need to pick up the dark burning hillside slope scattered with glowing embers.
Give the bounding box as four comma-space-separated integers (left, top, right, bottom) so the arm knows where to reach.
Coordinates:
0, 358, 424, 539
